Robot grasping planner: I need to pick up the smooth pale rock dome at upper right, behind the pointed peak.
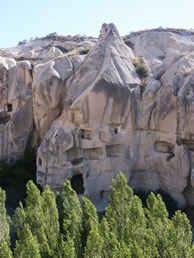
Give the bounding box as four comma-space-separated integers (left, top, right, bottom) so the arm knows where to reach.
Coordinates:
130, 31, 194, 78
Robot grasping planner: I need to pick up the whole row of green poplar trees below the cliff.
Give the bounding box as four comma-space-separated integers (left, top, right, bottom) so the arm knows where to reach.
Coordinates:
0, 173, 194, 258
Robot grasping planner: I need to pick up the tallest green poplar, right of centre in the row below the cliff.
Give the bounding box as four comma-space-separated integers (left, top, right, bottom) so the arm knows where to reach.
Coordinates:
105, 173, 158, 257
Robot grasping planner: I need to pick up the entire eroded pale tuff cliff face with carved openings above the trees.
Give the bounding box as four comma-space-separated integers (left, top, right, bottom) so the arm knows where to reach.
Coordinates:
0, 24, 194, 206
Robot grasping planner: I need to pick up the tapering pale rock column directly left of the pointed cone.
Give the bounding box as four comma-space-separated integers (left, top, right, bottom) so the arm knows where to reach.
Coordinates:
32, 56, 84, 141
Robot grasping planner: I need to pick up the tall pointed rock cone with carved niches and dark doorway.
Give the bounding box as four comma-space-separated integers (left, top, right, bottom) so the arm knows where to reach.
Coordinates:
37, 24, 140, 208
